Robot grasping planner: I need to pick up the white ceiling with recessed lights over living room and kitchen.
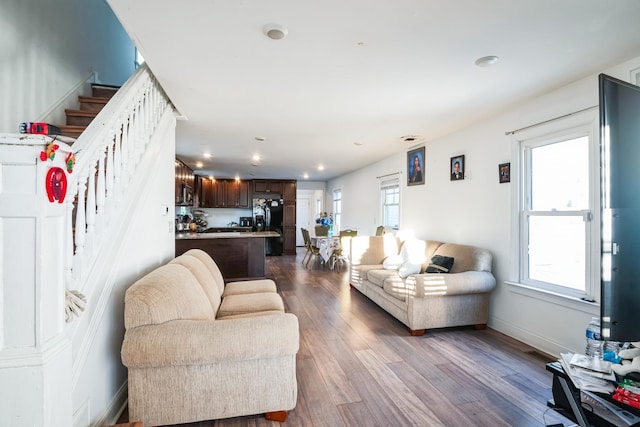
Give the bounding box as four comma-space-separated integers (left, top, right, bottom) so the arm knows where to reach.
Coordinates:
108, 0, 640, 180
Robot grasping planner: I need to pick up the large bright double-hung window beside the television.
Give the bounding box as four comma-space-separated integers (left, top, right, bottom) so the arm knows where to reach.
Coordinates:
516, 113, 600, 299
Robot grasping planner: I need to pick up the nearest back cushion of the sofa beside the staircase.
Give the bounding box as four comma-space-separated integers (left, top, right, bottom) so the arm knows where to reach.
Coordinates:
124, 264, 215, 329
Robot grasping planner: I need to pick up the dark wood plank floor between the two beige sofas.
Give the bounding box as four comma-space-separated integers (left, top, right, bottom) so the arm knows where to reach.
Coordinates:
120, 248, 571, 427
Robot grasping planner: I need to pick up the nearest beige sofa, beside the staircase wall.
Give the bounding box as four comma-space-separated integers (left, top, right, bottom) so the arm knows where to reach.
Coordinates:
121, 249, 299, 426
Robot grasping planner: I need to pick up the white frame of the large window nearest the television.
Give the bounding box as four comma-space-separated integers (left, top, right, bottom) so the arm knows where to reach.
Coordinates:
507, 109, 600, 302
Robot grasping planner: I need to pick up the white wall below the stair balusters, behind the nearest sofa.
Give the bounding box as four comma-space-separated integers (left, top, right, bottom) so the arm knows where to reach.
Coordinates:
67, 111, 175, 427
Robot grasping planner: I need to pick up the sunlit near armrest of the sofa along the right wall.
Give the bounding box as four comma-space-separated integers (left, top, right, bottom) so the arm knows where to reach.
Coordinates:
405, 271, 496, 298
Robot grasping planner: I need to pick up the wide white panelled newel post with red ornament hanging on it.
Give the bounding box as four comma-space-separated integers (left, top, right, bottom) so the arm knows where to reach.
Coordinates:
0, 135, 73, 427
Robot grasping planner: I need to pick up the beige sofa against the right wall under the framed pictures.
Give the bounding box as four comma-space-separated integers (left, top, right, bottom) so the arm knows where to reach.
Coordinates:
350, 234, 496, 335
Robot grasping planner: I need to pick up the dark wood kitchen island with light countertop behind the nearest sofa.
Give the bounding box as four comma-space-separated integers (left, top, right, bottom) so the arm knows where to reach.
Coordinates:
176, 231, 280, 281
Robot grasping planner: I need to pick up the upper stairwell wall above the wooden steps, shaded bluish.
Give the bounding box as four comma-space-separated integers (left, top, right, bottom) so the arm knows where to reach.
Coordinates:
0, 0, 135, 133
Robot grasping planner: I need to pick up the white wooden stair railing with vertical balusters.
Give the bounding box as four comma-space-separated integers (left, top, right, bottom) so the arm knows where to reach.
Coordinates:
65, 64, 171, 296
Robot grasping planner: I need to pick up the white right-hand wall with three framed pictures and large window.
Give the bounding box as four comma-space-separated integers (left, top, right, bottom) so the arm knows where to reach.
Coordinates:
327, 58, 640, 355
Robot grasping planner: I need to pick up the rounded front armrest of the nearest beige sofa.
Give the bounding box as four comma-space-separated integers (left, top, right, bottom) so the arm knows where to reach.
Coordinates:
121, 313, 300, 368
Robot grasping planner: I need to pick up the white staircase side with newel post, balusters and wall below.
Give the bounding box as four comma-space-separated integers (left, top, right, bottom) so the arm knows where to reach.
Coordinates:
0, 66, 175, 426
